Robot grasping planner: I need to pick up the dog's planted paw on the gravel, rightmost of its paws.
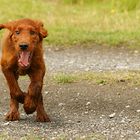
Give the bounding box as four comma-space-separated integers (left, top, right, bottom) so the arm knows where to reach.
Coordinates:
36, 113, 51, 122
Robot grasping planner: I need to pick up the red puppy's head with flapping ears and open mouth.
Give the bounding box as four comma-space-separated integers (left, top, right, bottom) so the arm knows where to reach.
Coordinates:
0, 19, 48, 68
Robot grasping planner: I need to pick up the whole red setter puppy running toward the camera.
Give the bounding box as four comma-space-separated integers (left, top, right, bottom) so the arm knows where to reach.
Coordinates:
0, 19, 50, 122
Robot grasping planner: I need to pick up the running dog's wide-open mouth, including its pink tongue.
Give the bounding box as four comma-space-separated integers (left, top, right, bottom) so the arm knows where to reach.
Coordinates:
18, 51, 32, 68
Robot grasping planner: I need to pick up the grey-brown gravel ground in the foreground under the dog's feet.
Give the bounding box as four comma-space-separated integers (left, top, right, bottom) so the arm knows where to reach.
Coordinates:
0, 82, 140, 140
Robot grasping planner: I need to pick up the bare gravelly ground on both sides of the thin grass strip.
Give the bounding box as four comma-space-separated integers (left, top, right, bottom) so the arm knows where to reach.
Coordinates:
0, 48, 140, 140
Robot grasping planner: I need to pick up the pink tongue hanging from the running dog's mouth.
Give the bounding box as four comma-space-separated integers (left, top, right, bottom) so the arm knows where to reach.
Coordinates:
18, 51, 30, 67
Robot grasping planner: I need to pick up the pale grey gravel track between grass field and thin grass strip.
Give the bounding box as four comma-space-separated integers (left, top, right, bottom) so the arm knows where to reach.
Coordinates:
45, 46, 140, 72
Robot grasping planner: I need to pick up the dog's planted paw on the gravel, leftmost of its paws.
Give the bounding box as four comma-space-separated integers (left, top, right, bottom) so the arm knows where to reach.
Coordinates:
5, 111, 20, 121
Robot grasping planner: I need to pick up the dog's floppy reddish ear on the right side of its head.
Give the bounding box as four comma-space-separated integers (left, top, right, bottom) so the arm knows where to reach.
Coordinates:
36, 21, 48, 38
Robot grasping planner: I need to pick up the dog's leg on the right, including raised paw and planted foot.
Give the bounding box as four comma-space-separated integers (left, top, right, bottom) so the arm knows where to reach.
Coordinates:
24, 70, 50, 122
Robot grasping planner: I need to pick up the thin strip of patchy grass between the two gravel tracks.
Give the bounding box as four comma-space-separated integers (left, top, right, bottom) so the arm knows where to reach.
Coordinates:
51, 71, 140, 85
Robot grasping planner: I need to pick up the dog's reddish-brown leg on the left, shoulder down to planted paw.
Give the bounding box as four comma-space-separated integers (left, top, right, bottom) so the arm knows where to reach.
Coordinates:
2, 67, 24, 121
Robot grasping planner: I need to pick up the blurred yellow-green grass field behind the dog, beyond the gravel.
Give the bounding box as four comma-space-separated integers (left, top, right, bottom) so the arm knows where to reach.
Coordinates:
0, 0, 140, 47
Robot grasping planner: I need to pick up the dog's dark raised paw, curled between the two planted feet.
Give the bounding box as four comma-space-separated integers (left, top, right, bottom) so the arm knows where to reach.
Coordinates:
23, 95, 37, 114
